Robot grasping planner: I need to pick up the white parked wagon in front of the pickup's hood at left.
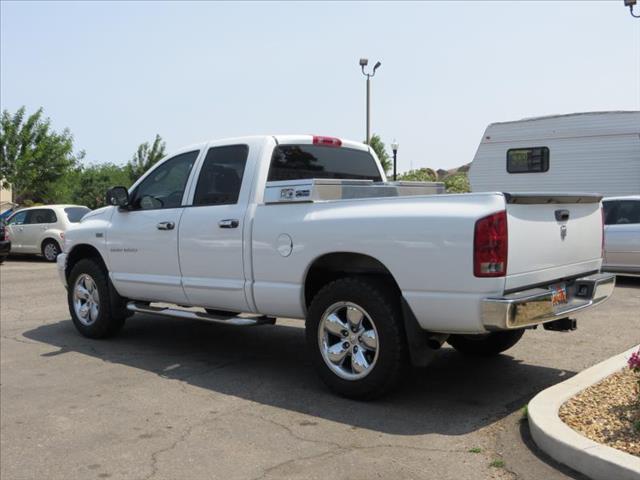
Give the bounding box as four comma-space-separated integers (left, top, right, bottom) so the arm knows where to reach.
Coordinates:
6, 205, 91, 262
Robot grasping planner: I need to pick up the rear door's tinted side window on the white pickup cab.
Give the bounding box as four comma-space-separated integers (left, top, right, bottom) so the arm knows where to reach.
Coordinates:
193, 145, 249, 206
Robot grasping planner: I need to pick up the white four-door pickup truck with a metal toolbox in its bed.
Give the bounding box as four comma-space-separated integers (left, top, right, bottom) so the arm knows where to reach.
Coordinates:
57, 135, 615, 398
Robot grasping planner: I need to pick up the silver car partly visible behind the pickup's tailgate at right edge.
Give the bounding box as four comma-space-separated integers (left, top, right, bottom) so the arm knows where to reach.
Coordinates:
602, 195, 640, 275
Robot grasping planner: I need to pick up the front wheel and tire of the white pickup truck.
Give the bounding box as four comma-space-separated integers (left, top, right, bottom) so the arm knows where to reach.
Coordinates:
67, 259, 129, 338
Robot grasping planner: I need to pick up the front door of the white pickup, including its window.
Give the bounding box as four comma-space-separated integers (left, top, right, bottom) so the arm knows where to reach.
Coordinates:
106, 150, 200, 304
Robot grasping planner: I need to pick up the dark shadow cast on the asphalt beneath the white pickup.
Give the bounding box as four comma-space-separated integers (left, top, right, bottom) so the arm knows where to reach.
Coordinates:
24, 315, 573, 435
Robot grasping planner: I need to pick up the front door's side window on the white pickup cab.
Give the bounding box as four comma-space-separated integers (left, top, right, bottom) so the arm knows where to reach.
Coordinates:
131, 150, 199, 210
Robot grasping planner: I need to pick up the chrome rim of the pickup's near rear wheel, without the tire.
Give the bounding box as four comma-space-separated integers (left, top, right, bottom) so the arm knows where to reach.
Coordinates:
318, 302, 379, 380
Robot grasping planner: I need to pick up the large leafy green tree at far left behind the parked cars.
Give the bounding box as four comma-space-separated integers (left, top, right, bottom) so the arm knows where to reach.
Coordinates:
0, 107, 84, 203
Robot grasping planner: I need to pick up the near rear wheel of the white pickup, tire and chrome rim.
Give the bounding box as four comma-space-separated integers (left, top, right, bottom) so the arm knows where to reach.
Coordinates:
306, 278, 409, 399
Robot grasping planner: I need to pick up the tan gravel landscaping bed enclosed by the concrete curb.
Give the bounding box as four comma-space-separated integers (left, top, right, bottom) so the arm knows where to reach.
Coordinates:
560, 368, 640, 457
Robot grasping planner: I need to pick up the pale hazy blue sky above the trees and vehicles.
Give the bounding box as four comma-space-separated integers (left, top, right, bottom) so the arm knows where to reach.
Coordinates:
0, 0, 640, 170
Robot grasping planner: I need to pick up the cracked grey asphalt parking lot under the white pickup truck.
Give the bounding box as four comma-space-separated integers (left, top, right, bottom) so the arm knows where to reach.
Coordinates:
0, 258, 640, 480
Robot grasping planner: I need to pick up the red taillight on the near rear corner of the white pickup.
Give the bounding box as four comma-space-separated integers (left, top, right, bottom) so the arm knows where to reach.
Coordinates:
473, 210, 509, 277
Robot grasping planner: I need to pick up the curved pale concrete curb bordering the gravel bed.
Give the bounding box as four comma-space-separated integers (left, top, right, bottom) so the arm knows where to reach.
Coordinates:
527, 345, 640, 480
